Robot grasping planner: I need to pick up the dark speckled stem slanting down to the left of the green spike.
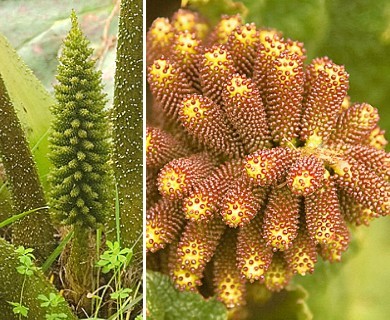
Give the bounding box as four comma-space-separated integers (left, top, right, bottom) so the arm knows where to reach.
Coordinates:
0, 74, 54, 259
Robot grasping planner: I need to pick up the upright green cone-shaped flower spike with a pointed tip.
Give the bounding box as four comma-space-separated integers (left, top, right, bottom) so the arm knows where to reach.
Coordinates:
49, 12, 113, 227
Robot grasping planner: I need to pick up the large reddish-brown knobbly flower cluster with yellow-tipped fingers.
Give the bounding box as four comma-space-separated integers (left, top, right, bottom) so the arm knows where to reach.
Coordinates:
146, 10, 390, 307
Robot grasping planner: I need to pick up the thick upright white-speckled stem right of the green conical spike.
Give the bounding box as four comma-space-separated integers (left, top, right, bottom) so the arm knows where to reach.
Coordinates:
113, 0, 143, 260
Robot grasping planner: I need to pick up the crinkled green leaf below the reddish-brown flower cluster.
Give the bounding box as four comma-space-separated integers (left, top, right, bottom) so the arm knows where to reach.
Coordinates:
146, 271, 227, 320
